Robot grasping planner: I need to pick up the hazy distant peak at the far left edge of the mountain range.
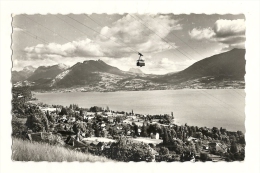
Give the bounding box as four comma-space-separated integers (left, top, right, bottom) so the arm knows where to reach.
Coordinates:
12, 66, 36, 83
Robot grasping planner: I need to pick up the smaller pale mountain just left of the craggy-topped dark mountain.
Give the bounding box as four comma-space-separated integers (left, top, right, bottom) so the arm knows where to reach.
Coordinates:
27, 64, 67, 82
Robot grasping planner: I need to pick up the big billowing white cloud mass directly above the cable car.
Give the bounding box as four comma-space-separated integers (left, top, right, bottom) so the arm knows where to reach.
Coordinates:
99, 14, 182, 53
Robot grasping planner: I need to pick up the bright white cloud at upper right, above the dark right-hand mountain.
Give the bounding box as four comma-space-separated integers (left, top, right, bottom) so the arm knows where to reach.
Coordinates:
189, 19, 246, 48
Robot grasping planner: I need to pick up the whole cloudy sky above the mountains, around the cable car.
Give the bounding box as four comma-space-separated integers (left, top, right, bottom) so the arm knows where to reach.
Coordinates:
12, 13, 246, 74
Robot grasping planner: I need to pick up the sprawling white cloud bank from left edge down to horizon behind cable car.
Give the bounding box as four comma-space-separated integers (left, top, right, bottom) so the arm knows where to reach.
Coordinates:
14, 14, 187, 74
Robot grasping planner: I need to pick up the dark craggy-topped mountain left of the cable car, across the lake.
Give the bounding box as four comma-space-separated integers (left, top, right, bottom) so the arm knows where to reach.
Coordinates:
52, 60, 127, 87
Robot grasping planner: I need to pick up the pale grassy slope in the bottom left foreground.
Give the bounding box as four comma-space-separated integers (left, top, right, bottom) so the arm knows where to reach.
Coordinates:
12, 138, 114, 162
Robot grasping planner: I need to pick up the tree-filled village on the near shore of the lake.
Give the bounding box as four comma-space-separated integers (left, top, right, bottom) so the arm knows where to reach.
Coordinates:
10, 86, 245, 162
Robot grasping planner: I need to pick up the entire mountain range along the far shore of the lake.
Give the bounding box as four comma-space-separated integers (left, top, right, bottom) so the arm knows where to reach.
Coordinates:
12, 49, 246, 91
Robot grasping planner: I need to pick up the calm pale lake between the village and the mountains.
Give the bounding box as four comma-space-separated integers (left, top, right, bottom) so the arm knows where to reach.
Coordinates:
31, 89, 245, 132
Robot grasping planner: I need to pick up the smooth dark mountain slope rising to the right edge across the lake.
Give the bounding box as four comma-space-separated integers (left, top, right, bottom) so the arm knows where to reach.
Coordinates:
161, 49, 246, 82
